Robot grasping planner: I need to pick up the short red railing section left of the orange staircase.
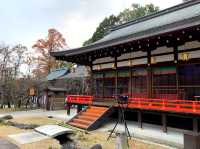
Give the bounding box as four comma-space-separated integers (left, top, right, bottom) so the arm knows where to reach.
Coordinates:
66, 95, 93, 105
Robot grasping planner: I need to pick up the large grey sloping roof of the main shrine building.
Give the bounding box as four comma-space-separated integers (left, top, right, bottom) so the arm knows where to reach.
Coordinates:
51, 0, 200, 59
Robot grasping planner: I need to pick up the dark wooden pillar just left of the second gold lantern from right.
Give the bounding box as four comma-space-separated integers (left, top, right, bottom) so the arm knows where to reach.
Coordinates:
147, 49, 153, 98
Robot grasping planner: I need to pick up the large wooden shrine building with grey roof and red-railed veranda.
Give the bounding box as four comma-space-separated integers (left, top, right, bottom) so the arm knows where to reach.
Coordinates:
51, 0, 200, 149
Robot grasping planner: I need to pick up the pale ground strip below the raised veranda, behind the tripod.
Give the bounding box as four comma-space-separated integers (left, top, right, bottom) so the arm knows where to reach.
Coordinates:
97, 121, 184, 148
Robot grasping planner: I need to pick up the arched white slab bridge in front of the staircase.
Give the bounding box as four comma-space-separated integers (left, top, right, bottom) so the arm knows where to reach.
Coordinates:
35, 125, 73, 137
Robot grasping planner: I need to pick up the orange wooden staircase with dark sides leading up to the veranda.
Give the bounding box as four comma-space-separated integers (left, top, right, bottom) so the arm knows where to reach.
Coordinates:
67, 106, 113, 130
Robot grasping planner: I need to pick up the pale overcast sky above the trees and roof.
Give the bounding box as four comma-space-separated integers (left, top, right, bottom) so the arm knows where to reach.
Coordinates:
0, 0, 182, 48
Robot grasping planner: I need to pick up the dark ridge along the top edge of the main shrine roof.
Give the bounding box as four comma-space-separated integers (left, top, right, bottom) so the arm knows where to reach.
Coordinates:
109, 0, 200, 33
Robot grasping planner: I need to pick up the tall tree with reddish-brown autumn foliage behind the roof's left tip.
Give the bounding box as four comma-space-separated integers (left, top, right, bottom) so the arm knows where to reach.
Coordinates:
32, 28, 67, 76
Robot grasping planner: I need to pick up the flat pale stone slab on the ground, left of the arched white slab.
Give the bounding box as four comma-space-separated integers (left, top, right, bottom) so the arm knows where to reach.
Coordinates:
8, 132, 49, 144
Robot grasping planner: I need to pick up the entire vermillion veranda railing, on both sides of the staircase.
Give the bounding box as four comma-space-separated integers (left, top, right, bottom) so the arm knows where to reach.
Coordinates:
66, 95, 200, 114
